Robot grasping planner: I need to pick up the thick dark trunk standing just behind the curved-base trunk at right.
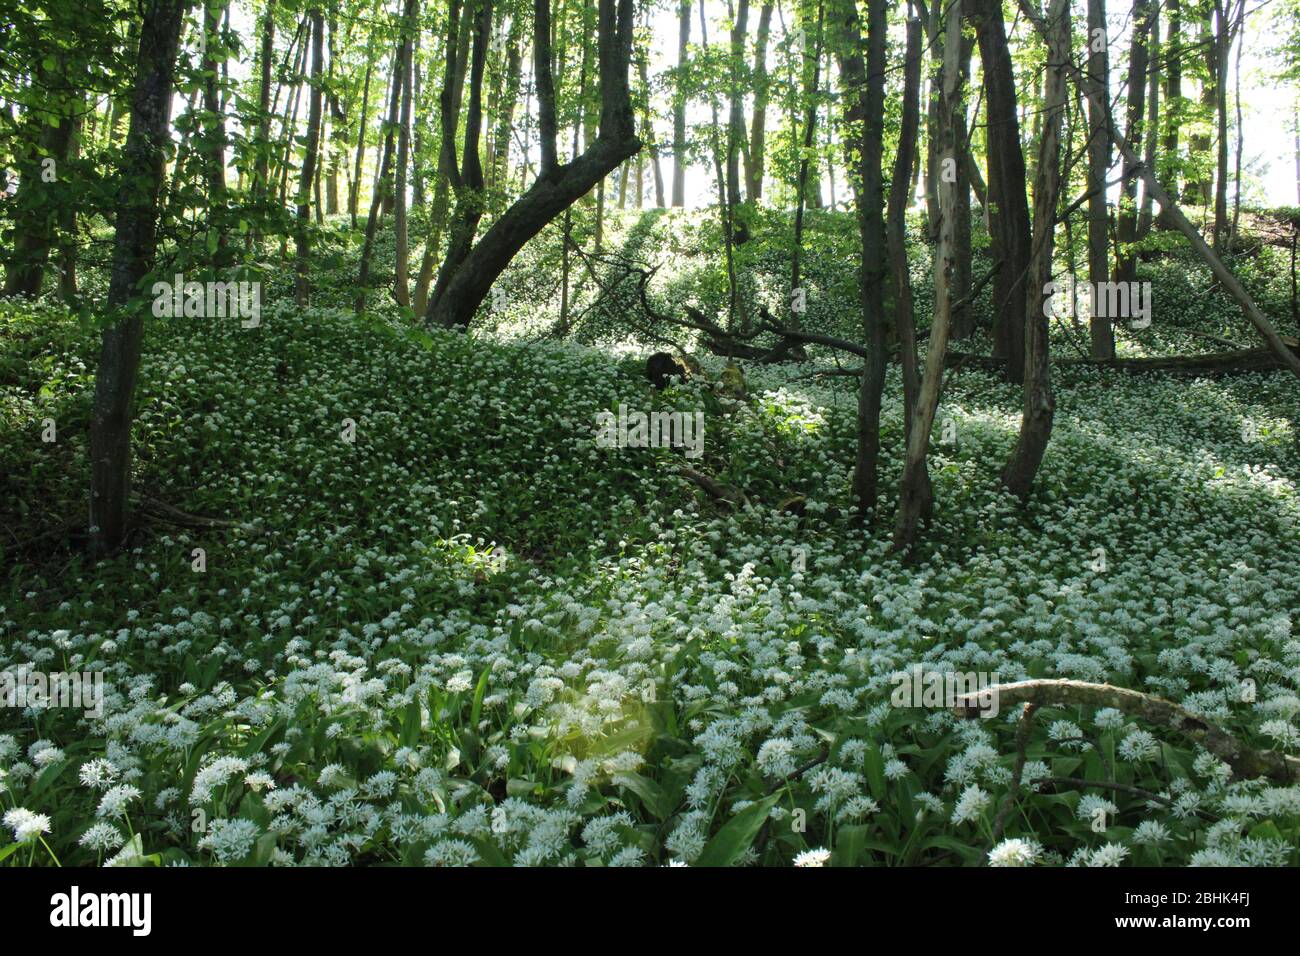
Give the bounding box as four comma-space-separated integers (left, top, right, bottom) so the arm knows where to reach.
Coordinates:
972, 0, 1030, 382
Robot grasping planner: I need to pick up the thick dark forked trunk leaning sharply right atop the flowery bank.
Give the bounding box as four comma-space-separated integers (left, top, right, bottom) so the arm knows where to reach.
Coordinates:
428, 0, 641, 329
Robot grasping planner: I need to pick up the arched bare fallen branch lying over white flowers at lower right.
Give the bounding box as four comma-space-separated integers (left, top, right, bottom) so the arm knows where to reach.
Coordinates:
953, 680, 1300, 783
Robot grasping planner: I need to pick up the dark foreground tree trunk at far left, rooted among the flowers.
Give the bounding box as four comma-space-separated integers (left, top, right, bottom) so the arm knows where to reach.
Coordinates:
90, 0, 187, 551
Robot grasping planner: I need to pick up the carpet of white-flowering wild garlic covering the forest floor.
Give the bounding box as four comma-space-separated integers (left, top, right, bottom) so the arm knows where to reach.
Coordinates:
0, 209, 1300, 865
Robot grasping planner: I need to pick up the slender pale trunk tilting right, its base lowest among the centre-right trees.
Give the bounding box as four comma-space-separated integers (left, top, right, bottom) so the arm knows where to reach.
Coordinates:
893, 0, 967, 550
